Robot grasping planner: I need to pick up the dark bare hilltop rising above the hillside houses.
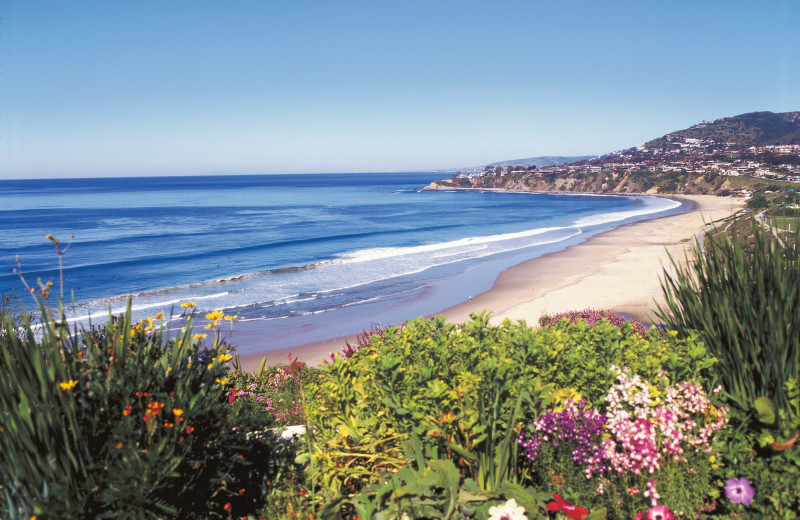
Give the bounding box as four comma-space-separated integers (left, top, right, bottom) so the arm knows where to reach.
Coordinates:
645, 112, 800, 148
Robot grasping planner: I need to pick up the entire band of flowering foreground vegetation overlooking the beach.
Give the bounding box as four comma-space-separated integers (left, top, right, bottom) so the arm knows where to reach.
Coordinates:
0, 221, 800, 520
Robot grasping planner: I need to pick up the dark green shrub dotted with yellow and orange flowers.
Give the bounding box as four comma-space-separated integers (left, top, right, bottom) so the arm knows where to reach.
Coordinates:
0, 305, 282, 518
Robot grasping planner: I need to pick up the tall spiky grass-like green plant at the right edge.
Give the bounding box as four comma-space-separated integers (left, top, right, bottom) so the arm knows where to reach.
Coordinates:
656, 220, 800, 410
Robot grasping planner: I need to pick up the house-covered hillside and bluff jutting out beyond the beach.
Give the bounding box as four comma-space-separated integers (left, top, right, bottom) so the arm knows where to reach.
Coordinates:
430, 112, 800, 197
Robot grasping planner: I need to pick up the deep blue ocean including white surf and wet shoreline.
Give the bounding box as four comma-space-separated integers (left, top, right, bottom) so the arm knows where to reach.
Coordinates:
0, 172, 684, 349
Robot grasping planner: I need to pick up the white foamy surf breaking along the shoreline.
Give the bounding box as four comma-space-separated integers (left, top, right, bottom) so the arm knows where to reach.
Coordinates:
57, 193, 681, 328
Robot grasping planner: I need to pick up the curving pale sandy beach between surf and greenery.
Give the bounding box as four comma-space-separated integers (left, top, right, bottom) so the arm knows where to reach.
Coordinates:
242, 195, 745, 370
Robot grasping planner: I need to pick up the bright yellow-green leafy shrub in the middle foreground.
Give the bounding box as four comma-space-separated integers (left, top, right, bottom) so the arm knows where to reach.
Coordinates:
304, 315, 714, 508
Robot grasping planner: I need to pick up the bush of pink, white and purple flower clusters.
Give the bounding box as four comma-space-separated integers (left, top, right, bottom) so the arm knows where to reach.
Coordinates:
519, 369, 727, 518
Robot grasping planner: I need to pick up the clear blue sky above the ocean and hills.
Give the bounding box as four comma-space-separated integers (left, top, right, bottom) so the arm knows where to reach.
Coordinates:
0, 0, 800, 178
